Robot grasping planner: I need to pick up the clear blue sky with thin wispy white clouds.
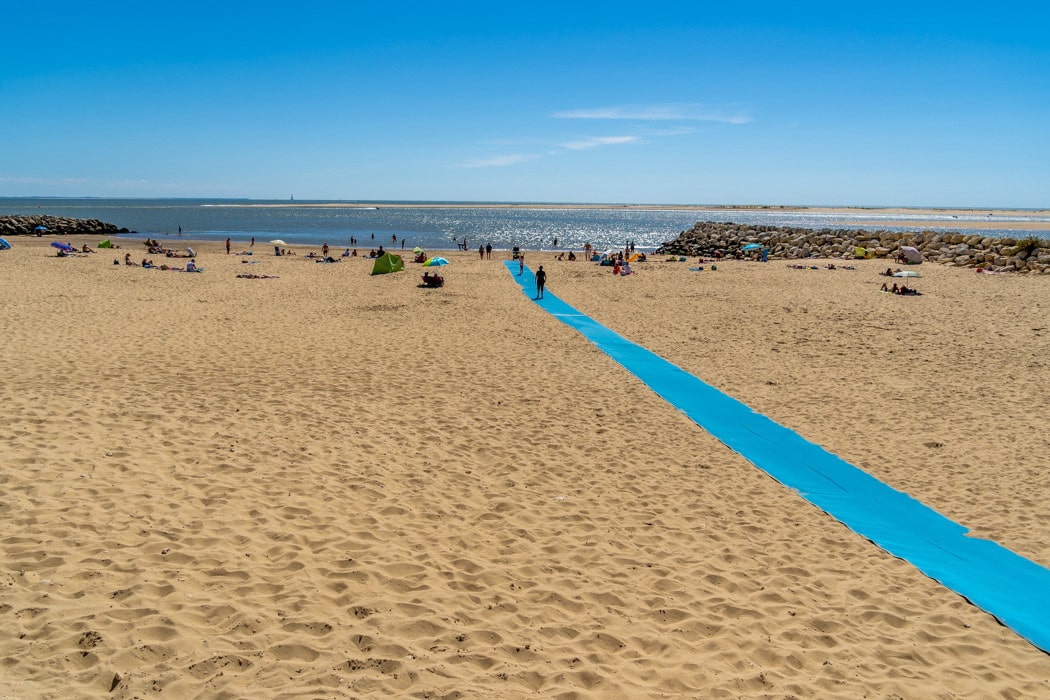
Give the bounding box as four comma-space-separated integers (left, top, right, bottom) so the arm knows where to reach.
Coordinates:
0, 0, 1050, 208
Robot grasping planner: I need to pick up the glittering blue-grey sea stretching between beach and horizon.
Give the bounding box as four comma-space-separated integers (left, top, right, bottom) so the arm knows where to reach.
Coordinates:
0, 197, 1050, 251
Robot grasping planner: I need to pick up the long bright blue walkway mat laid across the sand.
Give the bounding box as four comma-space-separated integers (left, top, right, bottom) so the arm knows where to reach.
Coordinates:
506, 261, 1050, 652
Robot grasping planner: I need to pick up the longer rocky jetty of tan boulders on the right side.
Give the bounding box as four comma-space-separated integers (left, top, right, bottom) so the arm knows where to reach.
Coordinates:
656, 221, 1050, 274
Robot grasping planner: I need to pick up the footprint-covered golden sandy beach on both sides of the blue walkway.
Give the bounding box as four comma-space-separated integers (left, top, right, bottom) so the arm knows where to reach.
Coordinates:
0, 238, 1050, 698
